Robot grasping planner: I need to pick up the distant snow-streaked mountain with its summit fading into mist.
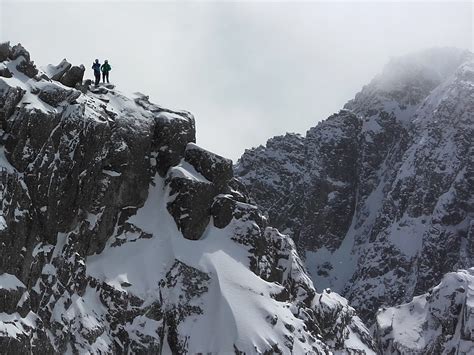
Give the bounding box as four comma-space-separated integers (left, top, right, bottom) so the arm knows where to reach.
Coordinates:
236, 49, 474, 321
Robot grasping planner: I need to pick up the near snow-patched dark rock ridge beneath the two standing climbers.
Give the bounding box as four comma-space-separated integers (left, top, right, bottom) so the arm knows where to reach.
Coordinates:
0, 44, 374, 354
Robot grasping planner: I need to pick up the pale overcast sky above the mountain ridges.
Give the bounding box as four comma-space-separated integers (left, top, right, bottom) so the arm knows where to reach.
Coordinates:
0, 0, 474, 160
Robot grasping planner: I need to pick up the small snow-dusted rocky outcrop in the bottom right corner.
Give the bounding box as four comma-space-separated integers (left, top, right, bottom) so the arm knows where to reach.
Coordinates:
376, 268, 474, 354
